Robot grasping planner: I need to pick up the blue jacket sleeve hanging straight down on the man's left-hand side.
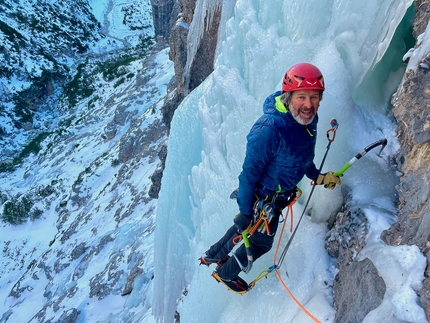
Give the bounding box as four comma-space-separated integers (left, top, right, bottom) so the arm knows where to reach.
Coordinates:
237, 124, 279, 217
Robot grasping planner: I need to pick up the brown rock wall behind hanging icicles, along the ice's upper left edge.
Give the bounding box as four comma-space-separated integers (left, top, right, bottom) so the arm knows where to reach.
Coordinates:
150, 0, 222, 198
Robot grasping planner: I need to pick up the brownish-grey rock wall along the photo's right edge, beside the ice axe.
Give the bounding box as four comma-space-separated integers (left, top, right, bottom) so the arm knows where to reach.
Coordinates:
381, 0, 430, 321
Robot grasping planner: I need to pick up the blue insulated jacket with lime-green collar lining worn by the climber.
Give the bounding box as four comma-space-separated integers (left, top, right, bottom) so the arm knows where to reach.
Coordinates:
237, 91, 319, 216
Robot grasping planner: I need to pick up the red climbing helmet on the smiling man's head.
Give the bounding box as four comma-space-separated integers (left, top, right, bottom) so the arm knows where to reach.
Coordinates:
282, 63, 324, 92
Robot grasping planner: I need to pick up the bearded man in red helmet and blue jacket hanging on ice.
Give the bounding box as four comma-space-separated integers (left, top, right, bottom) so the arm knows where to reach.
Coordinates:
200, 63, 341, 292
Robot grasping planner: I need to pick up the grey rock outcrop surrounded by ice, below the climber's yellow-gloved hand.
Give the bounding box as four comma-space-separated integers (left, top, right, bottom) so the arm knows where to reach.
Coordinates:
325, 187, 386, 323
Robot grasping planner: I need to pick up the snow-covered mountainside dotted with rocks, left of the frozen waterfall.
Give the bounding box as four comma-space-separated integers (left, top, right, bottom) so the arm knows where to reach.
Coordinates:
0, 1, 173, 322
